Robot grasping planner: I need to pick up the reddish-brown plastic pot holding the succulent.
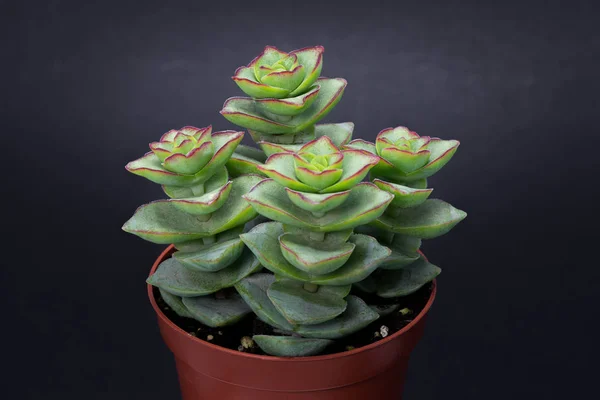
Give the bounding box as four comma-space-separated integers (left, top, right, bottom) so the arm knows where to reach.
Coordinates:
148, 246, 436, 400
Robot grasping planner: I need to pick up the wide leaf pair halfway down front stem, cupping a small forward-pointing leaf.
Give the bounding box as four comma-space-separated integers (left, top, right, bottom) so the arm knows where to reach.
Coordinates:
240, 222, 391, 286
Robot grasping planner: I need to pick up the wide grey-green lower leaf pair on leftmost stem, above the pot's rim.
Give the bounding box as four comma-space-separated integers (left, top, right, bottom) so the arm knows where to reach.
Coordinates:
146, 250, 261, 297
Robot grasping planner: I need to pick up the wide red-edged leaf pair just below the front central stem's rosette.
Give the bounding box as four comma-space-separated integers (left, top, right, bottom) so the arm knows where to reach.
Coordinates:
244, 179, 394, 232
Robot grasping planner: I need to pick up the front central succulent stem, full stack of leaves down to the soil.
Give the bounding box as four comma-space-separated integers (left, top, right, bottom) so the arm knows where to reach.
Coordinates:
236, 136, 393, 356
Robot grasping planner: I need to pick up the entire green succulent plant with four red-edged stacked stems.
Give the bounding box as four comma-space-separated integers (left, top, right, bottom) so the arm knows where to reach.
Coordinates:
123, 46, 466, 357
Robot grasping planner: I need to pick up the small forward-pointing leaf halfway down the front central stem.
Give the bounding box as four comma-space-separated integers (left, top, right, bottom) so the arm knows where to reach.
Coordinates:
279, 233, 355, 275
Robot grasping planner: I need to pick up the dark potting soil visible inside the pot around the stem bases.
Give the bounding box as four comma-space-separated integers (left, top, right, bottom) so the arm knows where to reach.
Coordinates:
153, 283, 433, 355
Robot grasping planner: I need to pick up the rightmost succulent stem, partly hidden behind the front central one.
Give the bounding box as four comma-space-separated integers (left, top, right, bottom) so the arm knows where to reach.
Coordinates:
346, 126, 466, 298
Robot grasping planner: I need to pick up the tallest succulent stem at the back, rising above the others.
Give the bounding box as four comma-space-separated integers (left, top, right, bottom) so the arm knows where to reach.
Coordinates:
221, 46, 347, 144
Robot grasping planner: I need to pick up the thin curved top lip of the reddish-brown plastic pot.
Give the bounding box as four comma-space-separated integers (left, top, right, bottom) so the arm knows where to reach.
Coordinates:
146, 244, 437, 362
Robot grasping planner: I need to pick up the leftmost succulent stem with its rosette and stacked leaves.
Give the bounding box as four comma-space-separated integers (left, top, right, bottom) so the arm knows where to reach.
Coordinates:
123, 127, 262, 327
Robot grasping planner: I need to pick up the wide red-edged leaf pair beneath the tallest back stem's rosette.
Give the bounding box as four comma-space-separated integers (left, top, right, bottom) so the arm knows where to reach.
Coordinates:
221, 78, 347, 134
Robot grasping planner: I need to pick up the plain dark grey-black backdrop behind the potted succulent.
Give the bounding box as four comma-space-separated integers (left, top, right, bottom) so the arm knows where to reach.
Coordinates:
0, 0, 600, 400
